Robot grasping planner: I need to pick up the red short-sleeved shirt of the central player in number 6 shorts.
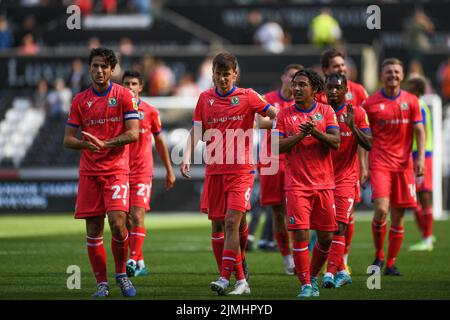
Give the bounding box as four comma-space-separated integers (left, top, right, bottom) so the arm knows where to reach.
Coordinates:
193, 86, 270, 175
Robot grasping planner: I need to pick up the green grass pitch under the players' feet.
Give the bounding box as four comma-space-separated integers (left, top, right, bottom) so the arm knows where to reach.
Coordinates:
0, 213, 450, 300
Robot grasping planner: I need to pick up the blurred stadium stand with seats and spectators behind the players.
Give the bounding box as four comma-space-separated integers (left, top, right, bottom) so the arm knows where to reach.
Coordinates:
0, 0, 450, 212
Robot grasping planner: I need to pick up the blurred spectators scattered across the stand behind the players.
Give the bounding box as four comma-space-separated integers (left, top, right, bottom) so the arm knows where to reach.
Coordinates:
0, 0, 450, 114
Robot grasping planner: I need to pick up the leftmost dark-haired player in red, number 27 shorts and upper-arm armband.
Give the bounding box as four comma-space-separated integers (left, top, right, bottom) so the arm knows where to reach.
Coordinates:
64, 48, 139, 297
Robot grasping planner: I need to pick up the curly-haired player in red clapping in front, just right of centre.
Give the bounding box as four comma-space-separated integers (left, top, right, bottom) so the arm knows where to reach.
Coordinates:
277, 70, 340, 298
